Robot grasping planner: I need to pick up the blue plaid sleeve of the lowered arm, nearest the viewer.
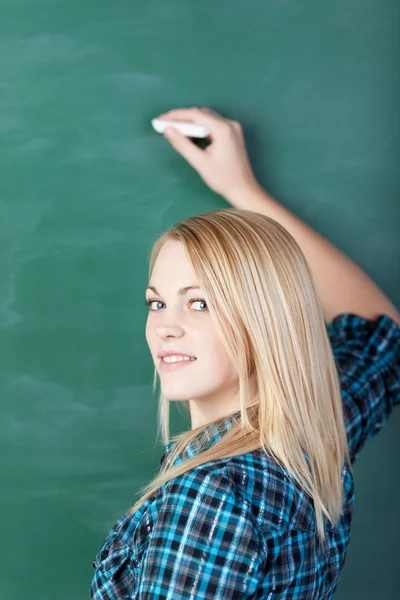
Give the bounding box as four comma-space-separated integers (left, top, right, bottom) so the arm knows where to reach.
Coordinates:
135, 467, 263, 600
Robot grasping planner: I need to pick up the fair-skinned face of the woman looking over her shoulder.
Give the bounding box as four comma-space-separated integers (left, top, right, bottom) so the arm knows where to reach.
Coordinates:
146, 240, 239, 427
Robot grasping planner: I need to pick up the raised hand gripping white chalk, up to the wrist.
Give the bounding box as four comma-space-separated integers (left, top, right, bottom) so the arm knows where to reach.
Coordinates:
158, 107, 259, 204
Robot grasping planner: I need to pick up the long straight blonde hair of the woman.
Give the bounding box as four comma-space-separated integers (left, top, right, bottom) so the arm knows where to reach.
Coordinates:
129, 208, 351, 541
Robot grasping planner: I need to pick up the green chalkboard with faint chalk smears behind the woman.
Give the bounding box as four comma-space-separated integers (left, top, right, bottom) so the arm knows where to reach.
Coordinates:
0, 0, 400, 600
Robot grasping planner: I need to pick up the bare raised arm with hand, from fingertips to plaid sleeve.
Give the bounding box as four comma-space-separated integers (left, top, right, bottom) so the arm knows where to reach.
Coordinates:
158, 108, 400, 325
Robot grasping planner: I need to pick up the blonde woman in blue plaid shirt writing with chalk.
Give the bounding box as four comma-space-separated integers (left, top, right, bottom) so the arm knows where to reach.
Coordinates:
90, 108, 400, 600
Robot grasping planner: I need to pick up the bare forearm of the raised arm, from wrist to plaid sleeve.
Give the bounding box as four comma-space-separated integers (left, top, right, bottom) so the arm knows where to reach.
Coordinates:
227, 187, 400, 325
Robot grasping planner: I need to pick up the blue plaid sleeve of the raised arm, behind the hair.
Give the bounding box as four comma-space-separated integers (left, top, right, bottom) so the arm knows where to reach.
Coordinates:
327, 313, 400, 462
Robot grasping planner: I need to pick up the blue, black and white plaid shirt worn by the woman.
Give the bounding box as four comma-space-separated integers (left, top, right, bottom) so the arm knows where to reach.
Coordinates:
90, 313, 400, 600
